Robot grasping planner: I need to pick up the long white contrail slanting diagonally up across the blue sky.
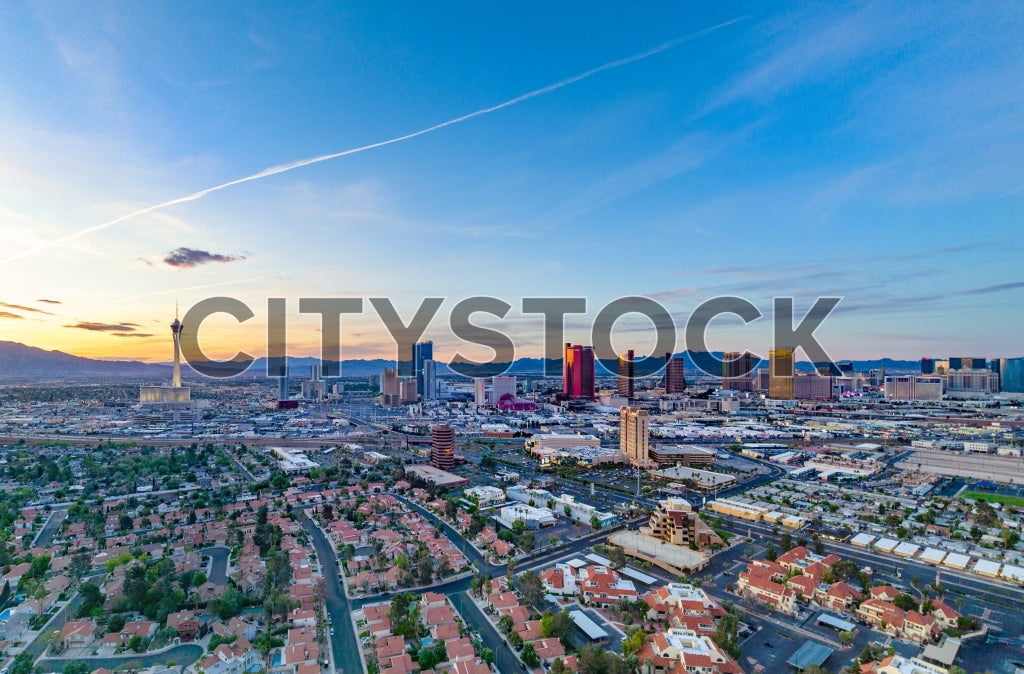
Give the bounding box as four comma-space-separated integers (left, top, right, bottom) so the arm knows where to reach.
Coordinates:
0, 16, 746, 264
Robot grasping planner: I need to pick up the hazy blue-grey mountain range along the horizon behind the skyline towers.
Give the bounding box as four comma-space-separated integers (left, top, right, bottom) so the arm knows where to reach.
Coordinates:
0, 341, 920, 380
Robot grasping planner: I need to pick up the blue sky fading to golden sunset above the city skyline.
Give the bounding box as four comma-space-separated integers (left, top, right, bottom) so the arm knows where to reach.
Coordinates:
0, 2, 1024, 361
